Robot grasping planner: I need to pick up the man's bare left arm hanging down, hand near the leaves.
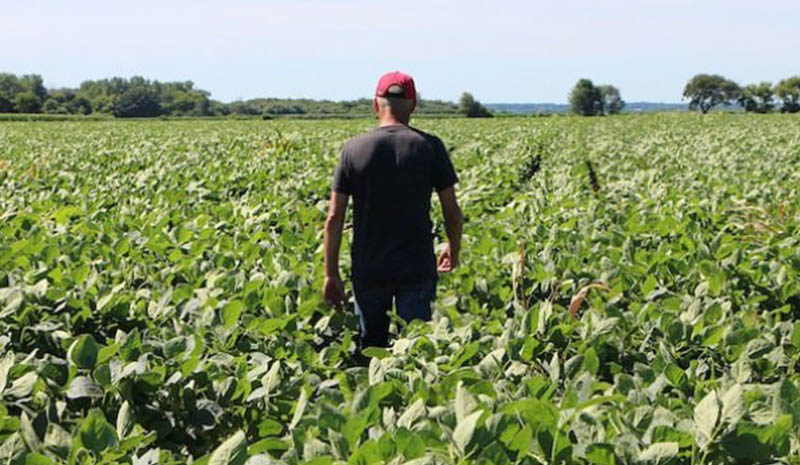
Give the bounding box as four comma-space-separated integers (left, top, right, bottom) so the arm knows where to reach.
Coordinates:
322, 191, 350, 307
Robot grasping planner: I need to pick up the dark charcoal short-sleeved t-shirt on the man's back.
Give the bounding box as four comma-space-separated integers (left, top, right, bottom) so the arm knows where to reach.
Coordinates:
333, 125, 458, 289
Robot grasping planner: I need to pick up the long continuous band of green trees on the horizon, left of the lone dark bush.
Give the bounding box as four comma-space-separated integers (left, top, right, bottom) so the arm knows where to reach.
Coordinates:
0, 73, 458, 117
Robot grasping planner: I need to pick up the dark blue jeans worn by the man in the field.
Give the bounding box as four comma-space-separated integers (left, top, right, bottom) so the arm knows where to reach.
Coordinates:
354, 282, 436, 349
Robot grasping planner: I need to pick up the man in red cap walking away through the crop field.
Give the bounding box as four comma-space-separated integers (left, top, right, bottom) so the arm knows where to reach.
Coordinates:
323, 71, 462, 348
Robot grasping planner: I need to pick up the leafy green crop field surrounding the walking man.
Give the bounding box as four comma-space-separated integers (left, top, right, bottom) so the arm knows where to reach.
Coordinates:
0, 114, 800, 465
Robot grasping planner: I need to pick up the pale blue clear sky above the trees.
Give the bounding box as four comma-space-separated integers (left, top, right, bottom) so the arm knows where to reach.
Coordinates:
0, 0, 800, 102
